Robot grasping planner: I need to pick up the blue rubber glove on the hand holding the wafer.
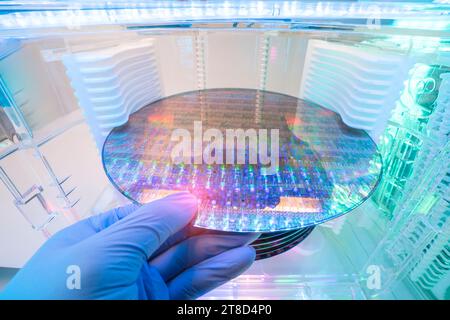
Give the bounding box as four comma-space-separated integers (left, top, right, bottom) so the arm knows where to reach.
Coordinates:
1, 192, 258, 299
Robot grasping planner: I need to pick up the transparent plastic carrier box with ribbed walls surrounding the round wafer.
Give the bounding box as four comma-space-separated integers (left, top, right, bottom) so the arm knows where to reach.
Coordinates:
0, 1, 450, 299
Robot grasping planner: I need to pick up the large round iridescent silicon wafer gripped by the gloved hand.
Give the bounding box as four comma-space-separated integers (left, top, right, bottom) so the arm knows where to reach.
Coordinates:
103, 89, 382, 232
